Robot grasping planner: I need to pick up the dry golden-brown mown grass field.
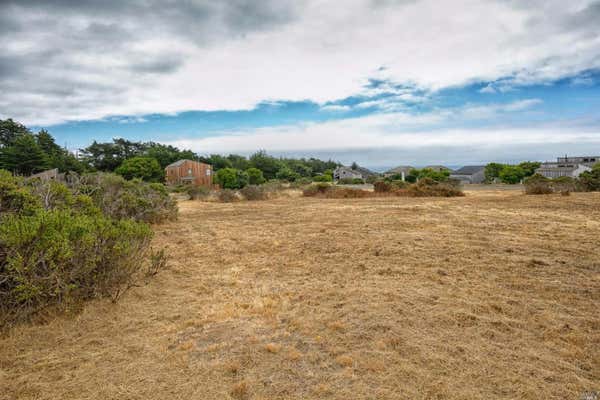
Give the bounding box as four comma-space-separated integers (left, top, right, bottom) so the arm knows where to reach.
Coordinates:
0, 190, 600, 400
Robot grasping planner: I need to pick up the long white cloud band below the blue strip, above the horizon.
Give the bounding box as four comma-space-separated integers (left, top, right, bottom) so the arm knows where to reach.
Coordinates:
164, 99, 600, 158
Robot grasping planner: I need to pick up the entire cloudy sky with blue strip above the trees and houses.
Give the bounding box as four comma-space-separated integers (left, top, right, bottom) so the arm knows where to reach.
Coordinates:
0, 0, 600, 169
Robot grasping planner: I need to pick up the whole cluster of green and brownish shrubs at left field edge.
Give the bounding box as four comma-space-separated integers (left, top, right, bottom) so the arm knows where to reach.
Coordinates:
0, 171, 176, 327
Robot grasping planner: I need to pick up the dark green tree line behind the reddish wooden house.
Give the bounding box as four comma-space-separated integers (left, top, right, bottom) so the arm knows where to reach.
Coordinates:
0, 119, 340, 188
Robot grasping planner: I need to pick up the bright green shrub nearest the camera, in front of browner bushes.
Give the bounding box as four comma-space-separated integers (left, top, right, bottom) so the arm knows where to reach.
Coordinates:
0, 210, 152, 325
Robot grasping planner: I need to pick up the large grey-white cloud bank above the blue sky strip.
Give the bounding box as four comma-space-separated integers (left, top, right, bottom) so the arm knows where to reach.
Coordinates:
0, 0, 600, 124
